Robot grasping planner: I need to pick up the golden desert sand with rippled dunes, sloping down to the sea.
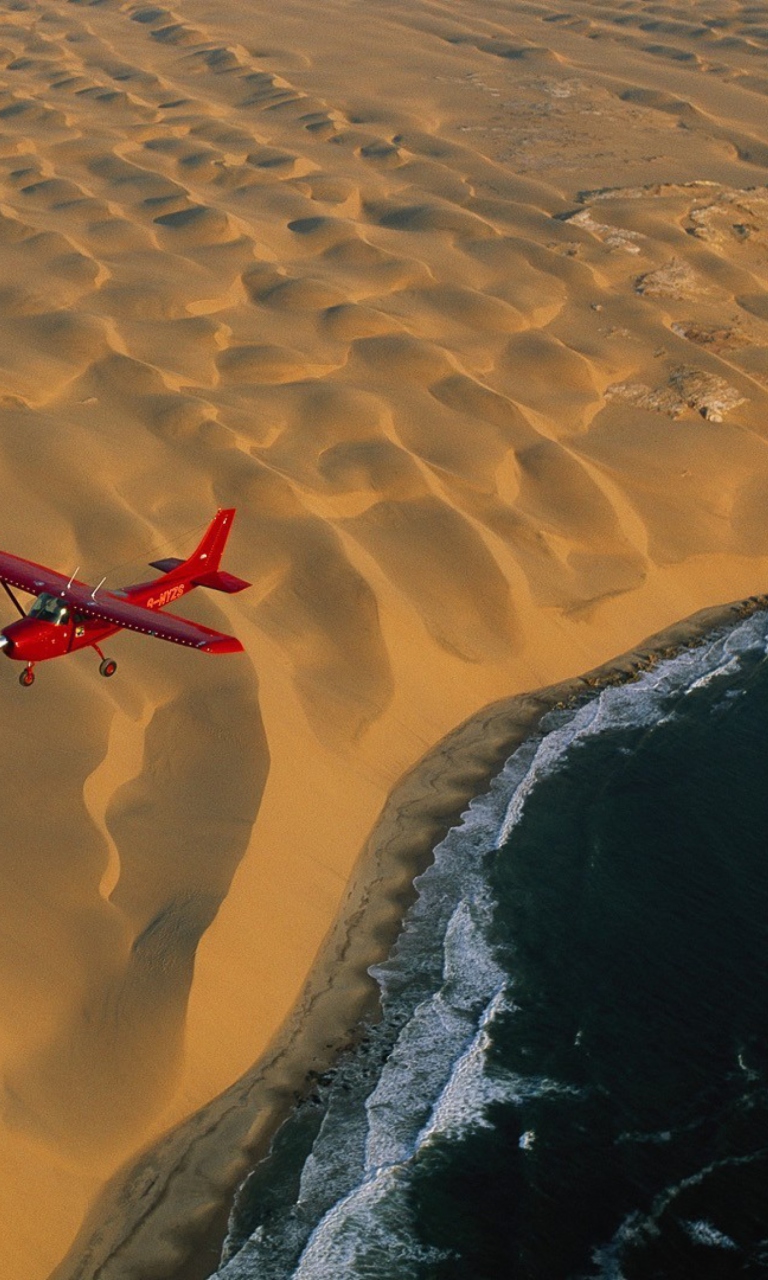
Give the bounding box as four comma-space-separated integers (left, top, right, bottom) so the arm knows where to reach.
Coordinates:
0, 0, 768, 1280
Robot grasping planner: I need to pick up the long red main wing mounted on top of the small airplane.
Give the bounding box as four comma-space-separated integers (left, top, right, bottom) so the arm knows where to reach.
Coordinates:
0, 552, 243, 653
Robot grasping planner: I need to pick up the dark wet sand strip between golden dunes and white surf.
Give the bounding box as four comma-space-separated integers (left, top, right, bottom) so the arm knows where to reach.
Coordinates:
50, 595, 768, 1280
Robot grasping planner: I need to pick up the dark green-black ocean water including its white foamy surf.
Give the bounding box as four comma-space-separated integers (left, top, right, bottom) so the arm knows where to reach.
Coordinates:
212, 613, 768, 1280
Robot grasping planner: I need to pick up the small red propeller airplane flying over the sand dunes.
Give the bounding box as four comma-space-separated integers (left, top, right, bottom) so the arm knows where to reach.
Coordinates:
0, 508, 251, 689
